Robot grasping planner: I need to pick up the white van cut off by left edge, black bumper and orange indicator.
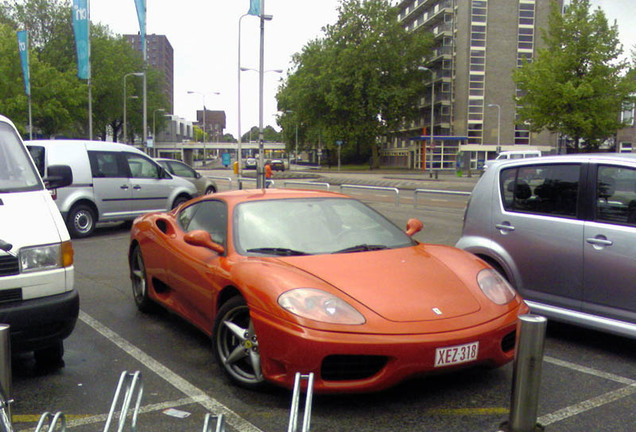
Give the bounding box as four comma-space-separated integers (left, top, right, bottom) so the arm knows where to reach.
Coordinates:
0, 116, 79, 366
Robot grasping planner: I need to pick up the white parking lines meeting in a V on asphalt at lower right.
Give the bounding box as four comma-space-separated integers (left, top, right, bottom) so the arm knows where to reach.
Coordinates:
537, 357, 636, 426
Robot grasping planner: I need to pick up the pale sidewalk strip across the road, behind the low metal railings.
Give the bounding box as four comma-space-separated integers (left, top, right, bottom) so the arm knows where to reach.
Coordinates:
201, 168, 479, 192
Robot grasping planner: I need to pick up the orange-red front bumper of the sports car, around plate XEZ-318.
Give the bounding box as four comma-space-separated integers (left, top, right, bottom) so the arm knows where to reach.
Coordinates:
252, 304, 528, 393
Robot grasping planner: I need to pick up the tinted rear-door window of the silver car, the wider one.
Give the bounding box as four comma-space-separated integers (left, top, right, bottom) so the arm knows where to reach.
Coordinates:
499, 164, 581, 217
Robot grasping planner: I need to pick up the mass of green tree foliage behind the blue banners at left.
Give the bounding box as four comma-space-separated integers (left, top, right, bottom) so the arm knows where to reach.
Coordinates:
0, 0, 169, 140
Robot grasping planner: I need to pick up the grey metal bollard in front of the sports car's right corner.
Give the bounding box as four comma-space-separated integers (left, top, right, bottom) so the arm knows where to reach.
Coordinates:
500, 314, 548, 432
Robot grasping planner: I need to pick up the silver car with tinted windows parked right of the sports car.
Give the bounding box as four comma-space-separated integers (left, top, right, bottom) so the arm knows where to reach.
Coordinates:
456, 154, 636, 338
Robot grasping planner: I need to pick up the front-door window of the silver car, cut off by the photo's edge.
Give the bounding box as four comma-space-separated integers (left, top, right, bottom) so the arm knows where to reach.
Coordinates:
595, 165, 636, 226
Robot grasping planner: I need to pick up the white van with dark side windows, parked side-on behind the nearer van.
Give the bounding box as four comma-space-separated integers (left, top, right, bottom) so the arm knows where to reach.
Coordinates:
26, 140, 199, 238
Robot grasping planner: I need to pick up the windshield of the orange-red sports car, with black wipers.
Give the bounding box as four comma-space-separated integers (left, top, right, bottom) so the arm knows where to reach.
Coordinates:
234, 198, 415, 256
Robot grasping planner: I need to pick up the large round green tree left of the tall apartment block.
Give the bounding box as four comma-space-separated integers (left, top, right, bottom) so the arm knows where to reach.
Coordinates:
277, 0, 432, 166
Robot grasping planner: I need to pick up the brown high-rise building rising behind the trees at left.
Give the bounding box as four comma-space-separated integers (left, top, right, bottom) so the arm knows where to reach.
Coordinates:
124, 34, 174, 113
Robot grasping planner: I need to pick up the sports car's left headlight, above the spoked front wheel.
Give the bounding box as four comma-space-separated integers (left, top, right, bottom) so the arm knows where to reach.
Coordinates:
278, 288, 366, 325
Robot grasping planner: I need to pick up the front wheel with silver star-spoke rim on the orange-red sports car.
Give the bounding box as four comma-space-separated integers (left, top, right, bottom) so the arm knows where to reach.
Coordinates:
213, 296, 265, 389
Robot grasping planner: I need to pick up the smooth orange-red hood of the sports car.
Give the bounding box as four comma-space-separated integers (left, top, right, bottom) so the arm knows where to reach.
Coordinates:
283, 246, 481, 322
